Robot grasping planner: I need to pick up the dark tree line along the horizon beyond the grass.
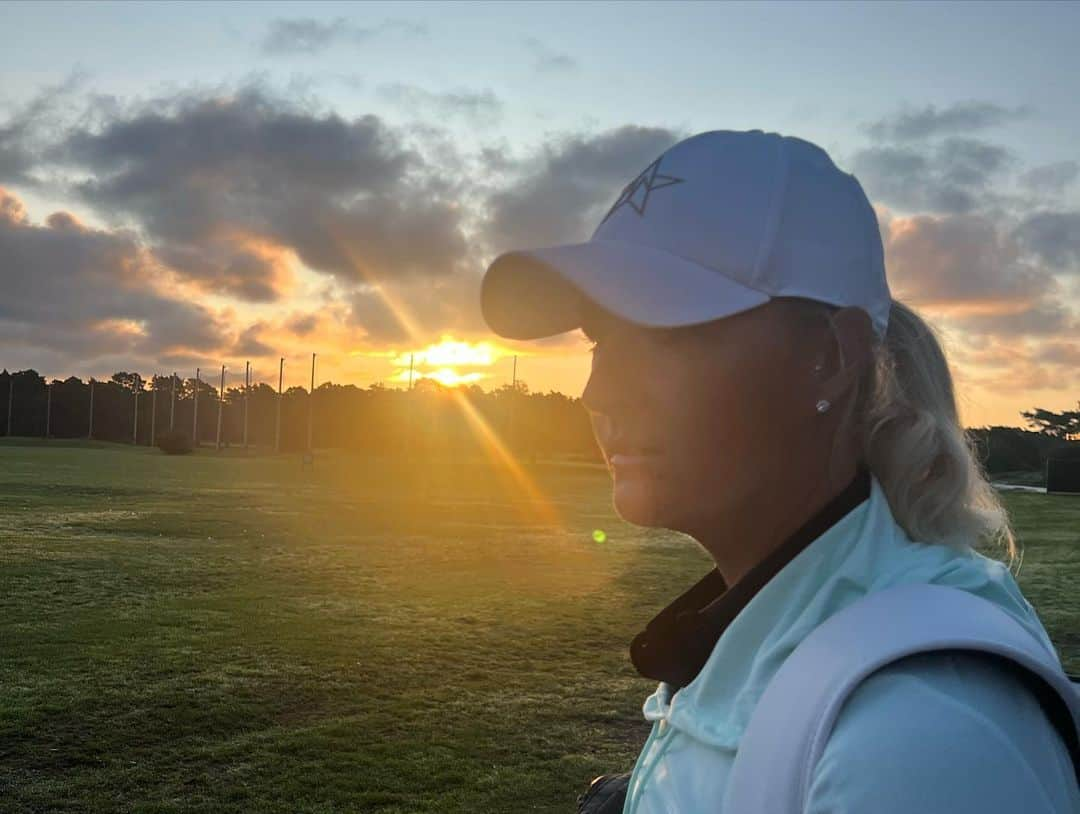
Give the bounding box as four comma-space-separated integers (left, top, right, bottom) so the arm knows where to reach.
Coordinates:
0, 370, 1080, 474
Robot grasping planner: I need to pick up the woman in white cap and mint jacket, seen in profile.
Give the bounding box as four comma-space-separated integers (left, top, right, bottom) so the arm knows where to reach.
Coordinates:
482, 131, 1080, 814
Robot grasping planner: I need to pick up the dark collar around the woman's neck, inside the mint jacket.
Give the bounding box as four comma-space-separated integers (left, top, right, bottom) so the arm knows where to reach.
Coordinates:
630, 466, 870, 691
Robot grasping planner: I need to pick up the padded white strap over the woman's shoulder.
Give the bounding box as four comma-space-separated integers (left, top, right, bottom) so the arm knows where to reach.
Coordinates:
724, 584, 1080, 814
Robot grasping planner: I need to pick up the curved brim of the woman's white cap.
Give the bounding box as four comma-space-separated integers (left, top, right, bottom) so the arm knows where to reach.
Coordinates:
481, 240, 770, 339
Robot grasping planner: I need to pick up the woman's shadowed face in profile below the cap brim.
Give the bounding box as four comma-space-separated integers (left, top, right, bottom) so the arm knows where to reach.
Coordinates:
582, 300, 816, 535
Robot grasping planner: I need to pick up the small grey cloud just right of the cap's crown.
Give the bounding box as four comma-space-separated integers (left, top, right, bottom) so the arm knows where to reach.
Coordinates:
851, 137, 1015, 214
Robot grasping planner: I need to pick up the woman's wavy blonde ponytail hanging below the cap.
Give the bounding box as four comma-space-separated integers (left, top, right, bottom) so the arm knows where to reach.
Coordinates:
790, 299, 1023, 573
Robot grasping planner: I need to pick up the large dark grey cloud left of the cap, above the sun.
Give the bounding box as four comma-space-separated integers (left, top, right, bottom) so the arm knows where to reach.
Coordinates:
57, 87, 465, 301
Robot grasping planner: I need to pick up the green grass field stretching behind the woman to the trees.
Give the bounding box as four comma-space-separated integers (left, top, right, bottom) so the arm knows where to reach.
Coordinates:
0, 445, 1080, 814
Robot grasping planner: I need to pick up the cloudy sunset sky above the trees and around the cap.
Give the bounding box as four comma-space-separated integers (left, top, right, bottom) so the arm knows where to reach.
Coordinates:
0, 2, 1080, 426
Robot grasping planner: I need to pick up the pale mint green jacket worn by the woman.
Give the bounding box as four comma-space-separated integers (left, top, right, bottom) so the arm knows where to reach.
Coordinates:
623, 477, 1080, 814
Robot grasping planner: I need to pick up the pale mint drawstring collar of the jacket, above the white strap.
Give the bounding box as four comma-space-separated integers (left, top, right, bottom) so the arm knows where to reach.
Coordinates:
643, 475, 1053, 750
